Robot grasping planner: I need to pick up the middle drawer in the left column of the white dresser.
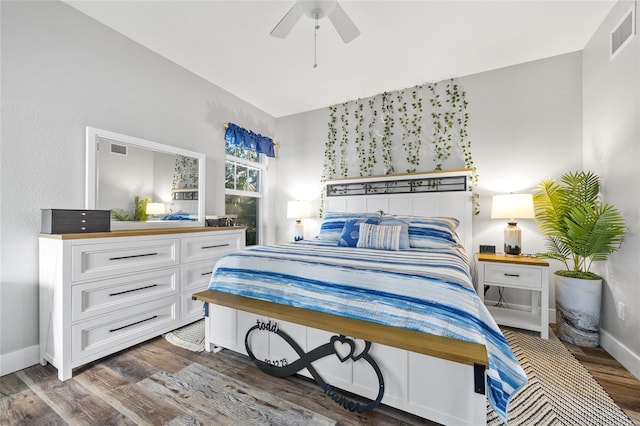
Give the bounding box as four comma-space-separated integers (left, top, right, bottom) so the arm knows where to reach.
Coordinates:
71, 267, 180, 321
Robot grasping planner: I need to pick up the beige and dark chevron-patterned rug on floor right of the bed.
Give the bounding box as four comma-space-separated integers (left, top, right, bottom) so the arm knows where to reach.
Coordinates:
487, 328, 634, 426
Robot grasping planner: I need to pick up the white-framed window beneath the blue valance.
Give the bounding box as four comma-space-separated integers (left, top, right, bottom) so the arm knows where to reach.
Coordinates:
225, 142, 266, 246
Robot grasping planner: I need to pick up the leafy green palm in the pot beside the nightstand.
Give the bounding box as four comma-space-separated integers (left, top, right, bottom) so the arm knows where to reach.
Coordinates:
533, 172, 626, 280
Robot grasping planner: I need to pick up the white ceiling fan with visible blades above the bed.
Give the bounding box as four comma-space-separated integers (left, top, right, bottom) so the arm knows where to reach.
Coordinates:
269, 0, 360, 43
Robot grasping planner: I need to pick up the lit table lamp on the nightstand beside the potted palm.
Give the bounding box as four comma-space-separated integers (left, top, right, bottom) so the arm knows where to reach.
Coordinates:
491, 194, 536, 256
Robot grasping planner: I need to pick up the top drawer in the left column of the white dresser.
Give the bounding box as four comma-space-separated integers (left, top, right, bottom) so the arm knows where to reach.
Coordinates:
71, 238, 179, 281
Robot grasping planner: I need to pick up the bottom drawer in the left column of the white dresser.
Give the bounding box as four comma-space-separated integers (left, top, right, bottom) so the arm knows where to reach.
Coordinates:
71, 296, 179, 362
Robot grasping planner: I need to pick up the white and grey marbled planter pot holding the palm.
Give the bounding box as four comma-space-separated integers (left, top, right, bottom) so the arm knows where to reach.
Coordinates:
555, 275, 602, 347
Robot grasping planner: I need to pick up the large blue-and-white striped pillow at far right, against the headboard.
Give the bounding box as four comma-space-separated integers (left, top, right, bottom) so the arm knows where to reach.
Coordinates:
396, 216, 462, 248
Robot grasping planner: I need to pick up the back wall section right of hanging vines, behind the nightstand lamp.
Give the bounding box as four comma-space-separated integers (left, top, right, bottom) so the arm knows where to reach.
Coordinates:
460, 52, 582, 310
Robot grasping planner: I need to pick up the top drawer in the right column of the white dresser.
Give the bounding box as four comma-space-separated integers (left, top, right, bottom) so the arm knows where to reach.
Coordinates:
181, 229, 244, 262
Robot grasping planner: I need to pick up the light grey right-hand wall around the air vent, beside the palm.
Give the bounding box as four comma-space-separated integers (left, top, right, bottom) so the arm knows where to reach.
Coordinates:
583, 1, 640, 377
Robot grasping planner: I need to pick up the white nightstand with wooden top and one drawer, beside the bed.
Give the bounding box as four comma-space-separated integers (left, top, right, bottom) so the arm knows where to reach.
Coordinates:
476, 253, 549, 339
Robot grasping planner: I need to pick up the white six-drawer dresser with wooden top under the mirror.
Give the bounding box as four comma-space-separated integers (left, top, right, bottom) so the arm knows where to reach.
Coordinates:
39, 227, 245, 380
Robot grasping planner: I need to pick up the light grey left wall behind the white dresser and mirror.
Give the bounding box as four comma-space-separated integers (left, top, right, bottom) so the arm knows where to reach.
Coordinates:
0, 1, 275, 374
